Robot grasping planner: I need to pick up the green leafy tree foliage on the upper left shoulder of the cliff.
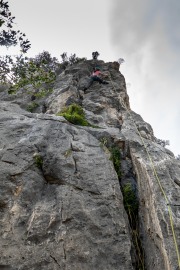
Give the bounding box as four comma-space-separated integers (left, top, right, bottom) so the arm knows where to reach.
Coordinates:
0, 51, 60, 93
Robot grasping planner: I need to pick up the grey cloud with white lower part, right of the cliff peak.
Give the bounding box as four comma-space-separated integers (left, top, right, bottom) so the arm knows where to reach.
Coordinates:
111, 0, 180, 155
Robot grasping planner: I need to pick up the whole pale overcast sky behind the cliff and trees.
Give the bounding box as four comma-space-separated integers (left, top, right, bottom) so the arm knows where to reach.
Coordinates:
2, 0, 180, 155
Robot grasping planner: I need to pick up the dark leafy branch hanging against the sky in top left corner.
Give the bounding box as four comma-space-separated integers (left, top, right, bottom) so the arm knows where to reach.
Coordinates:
0, 0, 31, 53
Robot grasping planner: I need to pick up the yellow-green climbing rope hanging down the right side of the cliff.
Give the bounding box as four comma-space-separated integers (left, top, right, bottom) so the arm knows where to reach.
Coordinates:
109, 72, 180, 269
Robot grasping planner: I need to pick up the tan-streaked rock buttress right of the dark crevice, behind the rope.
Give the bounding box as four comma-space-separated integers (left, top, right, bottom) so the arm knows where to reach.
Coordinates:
122, 110, 180, 270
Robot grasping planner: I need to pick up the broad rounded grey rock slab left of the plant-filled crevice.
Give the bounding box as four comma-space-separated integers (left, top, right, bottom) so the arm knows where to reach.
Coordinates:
0, 102, 133, 270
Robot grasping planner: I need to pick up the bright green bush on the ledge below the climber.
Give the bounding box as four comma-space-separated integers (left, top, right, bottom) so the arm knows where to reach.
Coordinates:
57, 104, 90, 126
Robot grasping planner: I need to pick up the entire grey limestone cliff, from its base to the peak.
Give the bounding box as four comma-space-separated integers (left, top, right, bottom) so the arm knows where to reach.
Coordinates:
0, 60, 180, 270
